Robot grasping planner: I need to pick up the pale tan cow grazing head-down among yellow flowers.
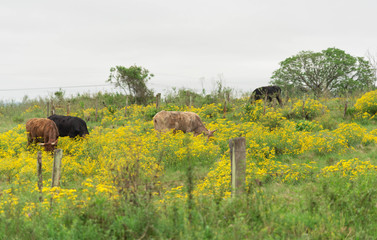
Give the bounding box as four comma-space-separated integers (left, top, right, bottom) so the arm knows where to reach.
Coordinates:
153, 111, 216, 138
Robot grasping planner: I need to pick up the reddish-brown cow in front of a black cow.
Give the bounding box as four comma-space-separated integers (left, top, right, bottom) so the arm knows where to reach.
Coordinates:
26, 118, 59, 151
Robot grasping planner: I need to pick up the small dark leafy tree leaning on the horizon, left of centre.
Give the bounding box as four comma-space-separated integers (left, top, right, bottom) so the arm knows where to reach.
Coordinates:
107, 65, 154, 104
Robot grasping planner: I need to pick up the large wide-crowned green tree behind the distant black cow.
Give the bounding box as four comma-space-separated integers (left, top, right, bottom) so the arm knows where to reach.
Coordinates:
270, 48, 376, 96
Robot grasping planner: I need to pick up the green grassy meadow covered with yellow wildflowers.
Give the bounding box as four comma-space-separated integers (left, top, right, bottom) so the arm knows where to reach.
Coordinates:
0, 91, 377, 239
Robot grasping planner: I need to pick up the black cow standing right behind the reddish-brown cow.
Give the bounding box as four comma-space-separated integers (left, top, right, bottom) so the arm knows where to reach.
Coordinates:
48, 114, 89, 138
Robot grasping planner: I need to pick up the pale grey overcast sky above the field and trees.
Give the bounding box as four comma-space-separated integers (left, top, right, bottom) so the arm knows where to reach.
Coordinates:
0, 0, 377, 101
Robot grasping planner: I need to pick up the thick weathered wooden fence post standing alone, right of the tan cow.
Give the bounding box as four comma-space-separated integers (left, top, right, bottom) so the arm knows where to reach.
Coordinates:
229, 137, 246, 197
